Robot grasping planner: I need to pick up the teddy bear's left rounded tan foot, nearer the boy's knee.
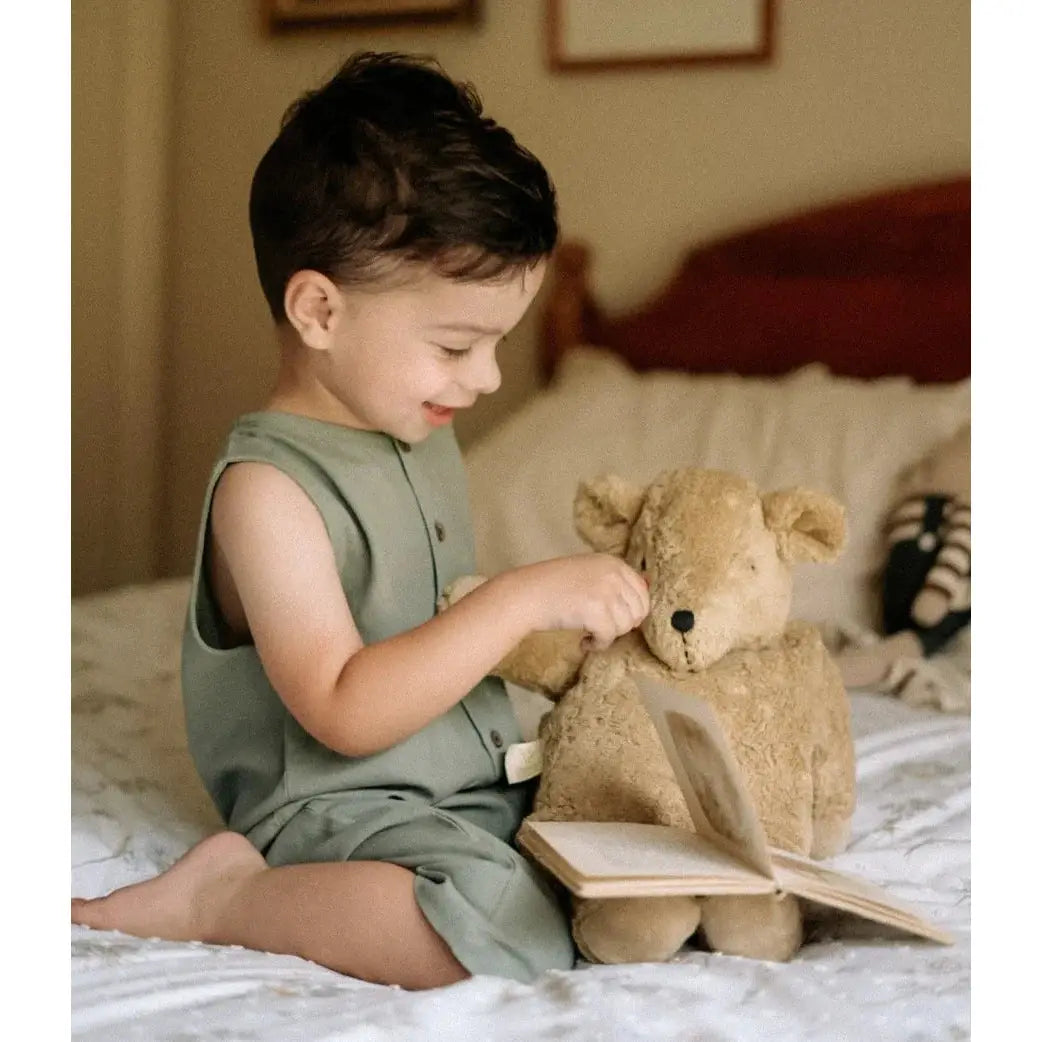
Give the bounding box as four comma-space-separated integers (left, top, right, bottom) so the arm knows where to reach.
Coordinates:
572, 896, 701, 963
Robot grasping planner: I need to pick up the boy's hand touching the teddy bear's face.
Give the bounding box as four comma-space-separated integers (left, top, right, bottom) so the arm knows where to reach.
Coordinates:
506, 553, 650, 649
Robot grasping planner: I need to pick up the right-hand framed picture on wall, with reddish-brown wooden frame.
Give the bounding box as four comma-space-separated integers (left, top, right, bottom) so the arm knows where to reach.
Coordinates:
544, 0, 774, 72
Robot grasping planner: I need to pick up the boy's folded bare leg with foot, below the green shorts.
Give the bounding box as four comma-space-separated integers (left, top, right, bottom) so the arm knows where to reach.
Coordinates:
72, 833, 469, 988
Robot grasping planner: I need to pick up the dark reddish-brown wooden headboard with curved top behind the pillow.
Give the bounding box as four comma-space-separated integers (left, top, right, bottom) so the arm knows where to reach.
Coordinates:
542, 177, 970, 382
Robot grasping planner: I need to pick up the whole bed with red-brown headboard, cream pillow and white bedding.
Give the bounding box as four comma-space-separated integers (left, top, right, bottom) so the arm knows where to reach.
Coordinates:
72, 179, 970, 1042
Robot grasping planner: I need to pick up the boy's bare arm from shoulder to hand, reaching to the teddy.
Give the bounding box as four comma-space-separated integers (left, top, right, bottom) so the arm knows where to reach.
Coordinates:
212, 464, 648, 756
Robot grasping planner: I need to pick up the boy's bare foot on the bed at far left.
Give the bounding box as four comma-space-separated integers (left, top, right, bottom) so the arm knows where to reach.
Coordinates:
72, 833, 267, 941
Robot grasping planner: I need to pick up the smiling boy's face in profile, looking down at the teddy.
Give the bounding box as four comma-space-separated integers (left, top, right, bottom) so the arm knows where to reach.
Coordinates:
318, 262, 546, 442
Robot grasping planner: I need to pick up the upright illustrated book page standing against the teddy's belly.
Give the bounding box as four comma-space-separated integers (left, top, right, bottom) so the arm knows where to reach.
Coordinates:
634, 676, 774, 878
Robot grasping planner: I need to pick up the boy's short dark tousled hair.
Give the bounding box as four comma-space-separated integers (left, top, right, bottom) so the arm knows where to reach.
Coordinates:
250, 52, 557, 322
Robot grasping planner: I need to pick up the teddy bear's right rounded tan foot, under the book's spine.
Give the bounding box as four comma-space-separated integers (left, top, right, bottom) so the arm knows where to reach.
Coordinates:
702, 894, 803, 963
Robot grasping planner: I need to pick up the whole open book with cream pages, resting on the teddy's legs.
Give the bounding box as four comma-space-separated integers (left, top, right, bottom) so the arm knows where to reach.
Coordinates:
518, 677, 952, 944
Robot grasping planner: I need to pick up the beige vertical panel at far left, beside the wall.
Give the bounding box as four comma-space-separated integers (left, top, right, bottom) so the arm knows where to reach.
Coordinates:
72, 0, 173, 592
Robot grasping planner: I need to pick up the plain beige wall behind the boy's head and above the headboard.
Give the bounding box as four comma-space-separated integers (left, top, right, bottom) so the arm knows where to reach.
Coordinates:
74, 0, 970, 591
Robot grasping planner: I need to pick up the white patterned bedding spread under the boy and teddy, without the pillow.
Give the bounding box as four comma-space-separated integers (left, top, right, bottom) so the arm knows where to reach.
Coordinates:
72, 581, 970, 1042
